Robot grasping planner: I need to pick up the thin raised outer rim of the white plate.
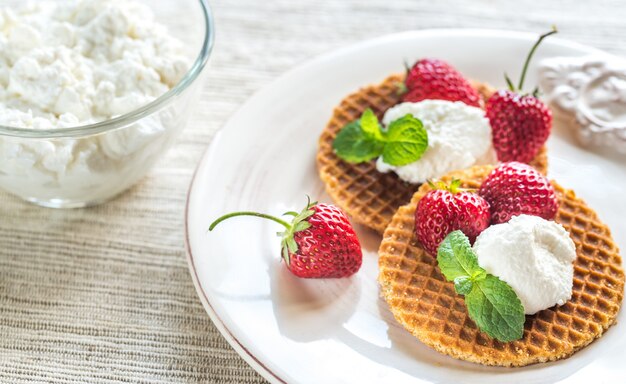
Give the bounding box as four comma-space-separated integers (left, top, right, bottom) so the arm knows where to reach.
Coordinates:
183, 28, 613, 384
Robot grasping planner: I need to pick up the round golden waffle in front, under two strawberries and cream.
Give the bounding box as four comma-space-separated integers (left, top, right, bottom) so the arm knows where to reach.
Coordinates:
378, 166, 624, 366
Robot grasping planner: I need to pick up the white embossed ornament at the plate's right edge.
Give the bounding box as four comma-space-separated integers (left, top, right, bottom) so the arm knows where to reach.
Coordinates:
539, 55, 626, 154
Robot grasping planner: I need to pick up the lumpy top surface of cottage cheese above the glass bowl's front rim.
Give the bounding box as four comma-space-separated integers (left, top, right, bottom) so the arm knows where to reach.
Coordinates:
0, 0, 188, 128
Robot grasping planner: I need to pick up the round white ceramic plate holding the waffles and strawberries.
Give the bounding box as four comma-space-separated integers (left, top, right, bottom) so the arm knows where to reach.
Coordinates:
186, 30, 626, 384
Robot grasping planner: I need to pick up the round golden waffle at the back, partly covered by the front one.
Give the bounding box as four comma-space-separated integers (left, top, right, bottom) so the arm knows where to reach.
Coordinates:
317, 75, 548, 234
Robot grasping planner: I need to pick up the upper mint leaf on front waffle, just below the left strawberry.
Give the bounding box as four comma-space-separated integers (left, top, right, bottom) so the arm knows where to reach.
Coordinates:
437, 230, 485, 281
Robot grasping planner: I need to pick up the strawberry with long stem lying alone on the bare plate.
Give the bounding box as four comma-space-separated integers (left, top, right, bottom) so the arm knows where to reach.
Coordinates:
209, 201, 363, 278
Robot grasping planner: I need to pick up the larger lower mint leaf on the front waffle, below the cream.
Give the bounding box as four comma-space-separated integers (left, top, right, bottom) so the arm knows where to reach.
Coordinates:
465, 274, 526, 342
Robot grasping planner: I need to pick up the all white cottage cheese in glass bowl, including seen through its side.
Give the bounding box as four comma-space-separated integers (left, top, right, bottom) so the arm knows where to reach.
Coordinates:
0, 0, 210, 206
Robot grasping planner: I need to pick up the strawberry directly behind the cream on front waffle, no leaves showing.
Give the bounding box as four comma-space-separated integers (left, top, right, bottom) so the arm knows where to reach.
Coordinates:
478, 162, 558, 224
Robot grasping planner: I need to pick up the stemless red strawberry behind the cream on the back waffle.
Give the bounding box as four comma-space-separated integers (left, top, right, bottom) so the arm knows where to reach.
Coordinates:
403, 59, 481, 107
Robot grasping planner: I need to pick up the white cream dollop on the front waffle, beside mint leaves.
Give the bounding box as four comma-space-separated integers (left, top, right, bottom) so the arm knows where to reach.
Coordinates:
474, 215, 576, 315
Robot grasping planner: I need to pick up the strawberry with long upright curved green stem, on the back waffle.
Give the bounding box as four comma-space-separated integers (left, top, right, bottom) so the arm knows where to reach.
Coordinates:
485, 29, 557, 163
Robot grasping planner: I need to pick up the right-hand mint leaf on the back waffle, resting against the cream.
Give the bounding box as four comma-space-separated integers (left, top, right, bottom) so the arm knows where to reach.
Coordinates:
383, 115, 428, 166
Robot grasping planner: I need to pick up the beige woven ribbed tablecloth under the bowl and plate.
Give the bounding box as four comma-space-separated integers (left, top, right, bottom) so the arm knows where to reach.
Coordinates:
0, 0, 626, 383
